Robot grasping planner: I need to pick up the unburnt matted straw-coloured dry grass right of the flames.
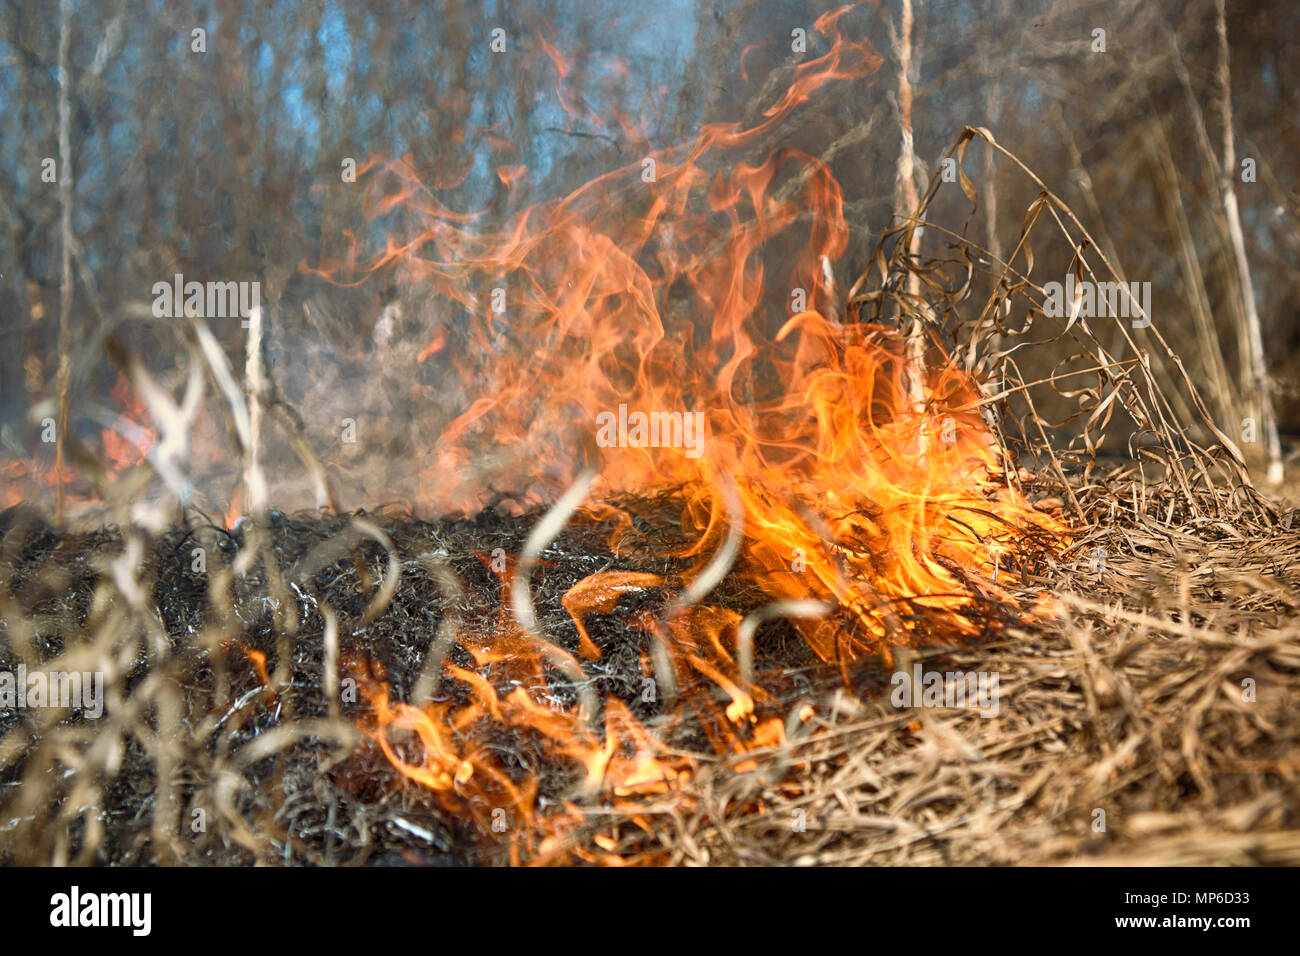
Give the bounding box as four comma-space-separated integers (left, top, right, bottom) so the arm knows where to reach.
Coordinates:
595, 478, 1300, 866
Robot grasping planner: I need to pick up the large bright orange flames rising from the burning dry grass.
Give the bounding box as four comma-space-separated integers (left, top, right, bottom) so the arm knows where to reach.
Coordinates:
312, 9, 1067, 861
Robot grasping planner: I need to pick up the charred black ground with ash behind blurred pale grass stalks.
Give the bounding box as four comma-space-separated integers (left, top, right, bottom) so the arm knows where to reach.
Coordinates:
0, 499, 839, 865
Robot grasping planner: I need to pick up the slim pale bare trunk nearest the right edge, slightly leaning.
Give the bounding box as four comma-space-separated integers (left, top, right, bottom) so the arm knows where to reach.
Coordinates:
1214, 0, 1283, 484
